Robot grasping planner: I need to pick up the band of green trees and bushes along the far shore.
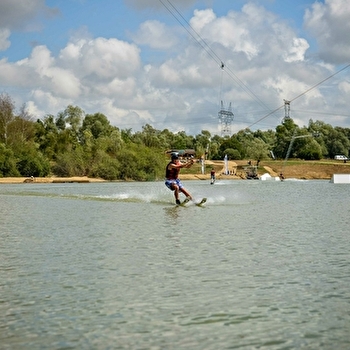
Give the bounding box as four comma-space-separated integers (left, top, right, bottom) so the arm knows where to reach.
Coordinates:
0, 93, 350, 181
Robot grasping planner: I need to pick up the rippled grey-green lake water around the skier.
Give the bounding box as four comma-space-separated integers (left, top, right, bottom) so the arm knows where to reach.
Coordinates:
0, 180, 350, 350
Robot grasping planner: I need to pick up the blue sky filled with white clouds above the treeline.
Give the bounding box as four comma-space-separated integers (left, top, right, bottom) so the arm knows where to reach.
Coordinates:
0, 0, 350, 135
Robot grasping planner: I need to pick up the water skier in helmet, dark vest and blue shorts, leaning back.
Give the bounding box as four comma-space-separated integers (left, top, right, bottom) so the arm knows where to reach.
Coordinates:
165, 152, 194, 204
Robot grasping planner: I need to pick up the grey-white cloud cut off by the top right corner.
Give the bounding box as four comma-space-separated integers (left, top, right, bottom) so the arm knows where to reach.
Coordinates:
304, 0, 350, 64
